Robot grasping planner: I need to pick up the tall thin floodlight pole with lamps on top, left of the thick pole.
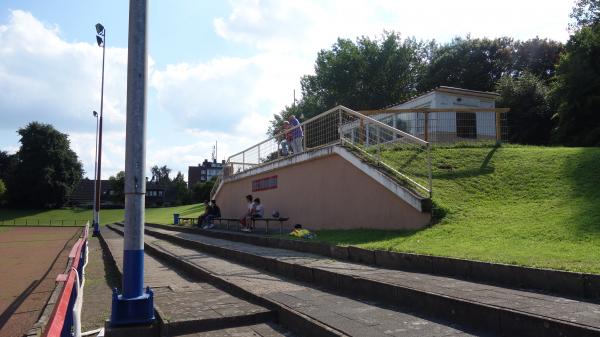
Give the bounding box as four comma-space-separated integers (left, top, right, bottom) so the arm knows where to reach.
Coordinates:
92, 23, 106, 235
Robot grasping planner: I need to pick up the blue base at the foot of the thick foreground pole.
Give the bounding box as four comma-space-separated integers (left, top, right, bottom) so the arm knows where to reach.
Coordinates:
110, 287, 155, 326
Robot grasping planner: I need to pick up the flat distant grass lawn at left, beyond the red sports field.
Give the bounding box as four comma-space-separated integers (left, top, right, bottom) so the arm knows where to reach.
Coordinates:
0, 204, 204, 225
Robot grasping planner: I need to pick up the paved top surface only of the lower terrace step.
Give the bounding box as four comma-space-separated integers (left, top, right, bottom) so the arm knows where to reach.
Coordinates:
120, 226, 473, 337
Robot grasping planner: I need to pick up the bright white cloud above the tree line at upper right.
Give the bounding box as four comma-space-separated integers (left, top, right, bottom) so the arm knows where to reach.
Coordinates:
213, 0, 573, 52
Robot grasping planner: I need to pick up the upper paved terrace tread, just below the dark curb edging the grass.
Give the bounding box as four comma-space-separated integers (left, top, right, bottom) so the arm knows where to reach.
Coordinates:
150, 224, 600, 328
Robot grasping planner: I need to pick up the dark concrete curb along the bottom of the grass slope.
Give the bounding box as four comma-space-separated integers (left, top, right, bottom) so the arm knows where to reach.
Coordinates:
146, 223, 600, 303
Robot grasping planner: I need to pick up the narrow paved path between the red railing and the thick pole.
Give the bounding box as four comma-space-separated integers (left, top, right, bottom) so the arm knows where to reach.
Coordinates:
81, 236, 121, 332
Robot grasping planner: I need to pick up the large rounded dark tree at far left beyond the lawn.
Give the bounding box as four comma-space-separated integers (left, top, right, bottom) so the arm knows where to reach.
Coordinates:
7, 122, 83, 207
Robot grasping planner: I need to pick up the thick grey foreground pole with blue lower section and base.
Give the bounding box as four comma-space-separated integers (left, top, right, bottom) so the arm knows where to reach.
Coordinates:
110, 0, 154, 326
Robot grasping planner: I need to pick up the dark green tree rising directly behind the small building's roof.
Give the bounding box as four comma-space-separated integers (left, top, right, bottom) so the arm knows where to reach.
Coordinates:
419, 36, 513, 91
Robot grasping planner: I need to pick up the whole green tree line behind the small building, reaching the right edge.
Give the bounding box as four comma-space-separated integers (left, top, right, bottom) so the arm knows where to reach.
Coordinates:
269, 0, 600, 146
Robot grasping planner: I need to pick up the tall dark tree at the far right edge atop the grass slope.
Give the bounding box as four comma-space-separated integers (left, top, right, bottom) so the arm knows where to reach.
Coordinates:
552, 24, 600, 146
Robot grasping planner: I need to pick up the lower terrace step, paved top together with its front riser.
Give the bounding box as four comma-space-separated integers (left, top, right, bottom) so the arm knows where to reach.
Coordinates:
108, 226, 480, 337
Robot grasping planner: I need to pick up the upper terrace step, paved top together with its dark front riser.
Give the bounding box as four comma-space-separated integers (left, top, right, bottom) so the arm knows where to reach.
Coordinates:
122, 223, 600, 336
